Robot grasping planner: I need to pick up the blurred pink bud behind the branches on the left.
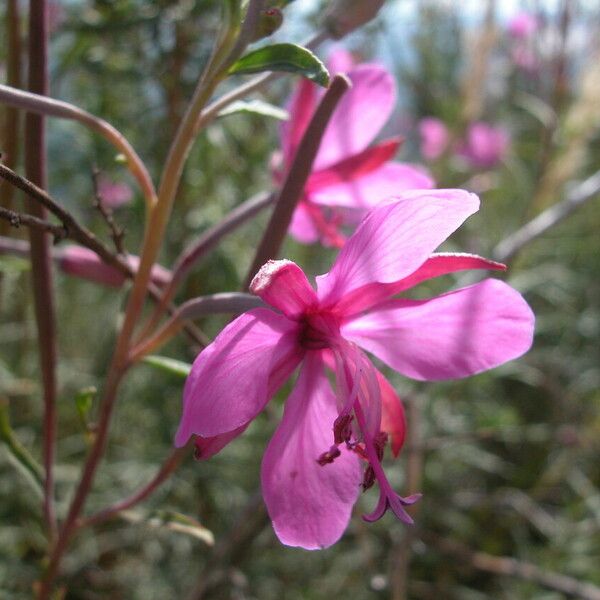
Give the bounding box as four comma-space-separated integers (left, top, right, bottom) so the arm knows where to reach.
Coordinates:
56, 245, 171, 287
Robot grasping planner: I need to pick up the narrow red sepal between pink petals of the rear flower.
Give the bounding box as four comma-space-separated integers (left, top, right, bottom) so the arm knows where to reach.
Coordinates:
305, 138, 400, 193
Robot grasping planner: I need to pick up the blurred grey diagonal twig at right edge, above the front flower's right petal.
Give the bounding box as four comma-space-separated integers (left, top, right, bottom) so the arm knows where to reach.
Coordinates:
493, 171, 600, 262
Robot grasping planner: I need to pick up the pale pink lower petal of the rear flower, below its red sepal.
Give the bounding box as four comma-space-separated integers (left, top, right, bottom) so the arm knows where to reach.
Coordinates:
307, 162, 434, 210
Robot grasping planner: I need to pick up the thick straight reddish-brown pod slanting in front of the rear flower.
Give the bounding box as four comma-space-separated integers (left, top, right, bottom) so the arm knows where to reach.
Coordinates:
244, 75, 351, 289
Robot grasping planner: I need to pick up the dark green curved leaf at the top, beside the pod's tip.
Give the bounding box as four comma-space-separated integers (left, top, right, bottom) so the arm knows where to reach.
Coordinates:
229, 44, 329, 87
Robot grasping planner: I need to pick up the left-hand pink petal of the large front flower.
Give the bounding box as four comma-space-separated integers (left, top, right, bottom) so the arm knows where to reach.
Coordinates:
175, 308, 302, 447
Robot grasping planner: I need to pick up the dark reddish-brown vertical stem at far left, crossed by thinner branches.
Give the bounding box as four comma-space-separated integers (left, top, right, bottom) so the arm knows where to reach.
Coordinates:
25, 0, 57, 540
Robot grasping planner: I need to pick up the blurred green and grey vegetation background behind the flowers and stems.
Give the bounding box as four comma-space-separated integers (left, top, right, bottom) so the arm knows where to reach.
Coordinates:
0, 0, 600, 600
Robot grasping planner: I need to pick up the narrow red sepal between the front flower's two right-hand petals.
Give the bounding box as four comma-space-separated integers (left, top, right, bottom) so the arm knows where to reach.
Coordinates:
336, 252, 506, 316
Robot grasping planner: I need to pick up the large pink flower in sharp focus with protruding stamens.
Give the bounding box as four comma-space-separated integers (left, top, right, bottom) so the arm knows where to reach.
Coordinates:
175, 190, 534, 549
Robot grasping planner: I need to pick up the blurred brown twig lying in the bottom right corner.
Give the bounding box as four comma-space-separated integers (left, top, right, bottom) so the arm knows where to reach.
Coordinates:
420, 531, 600, 600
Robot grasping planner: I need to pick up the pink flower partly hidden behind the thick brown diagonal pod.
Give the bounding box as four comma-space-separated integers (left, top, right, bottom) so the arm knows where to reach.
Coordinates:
274, 51, 434, 247
